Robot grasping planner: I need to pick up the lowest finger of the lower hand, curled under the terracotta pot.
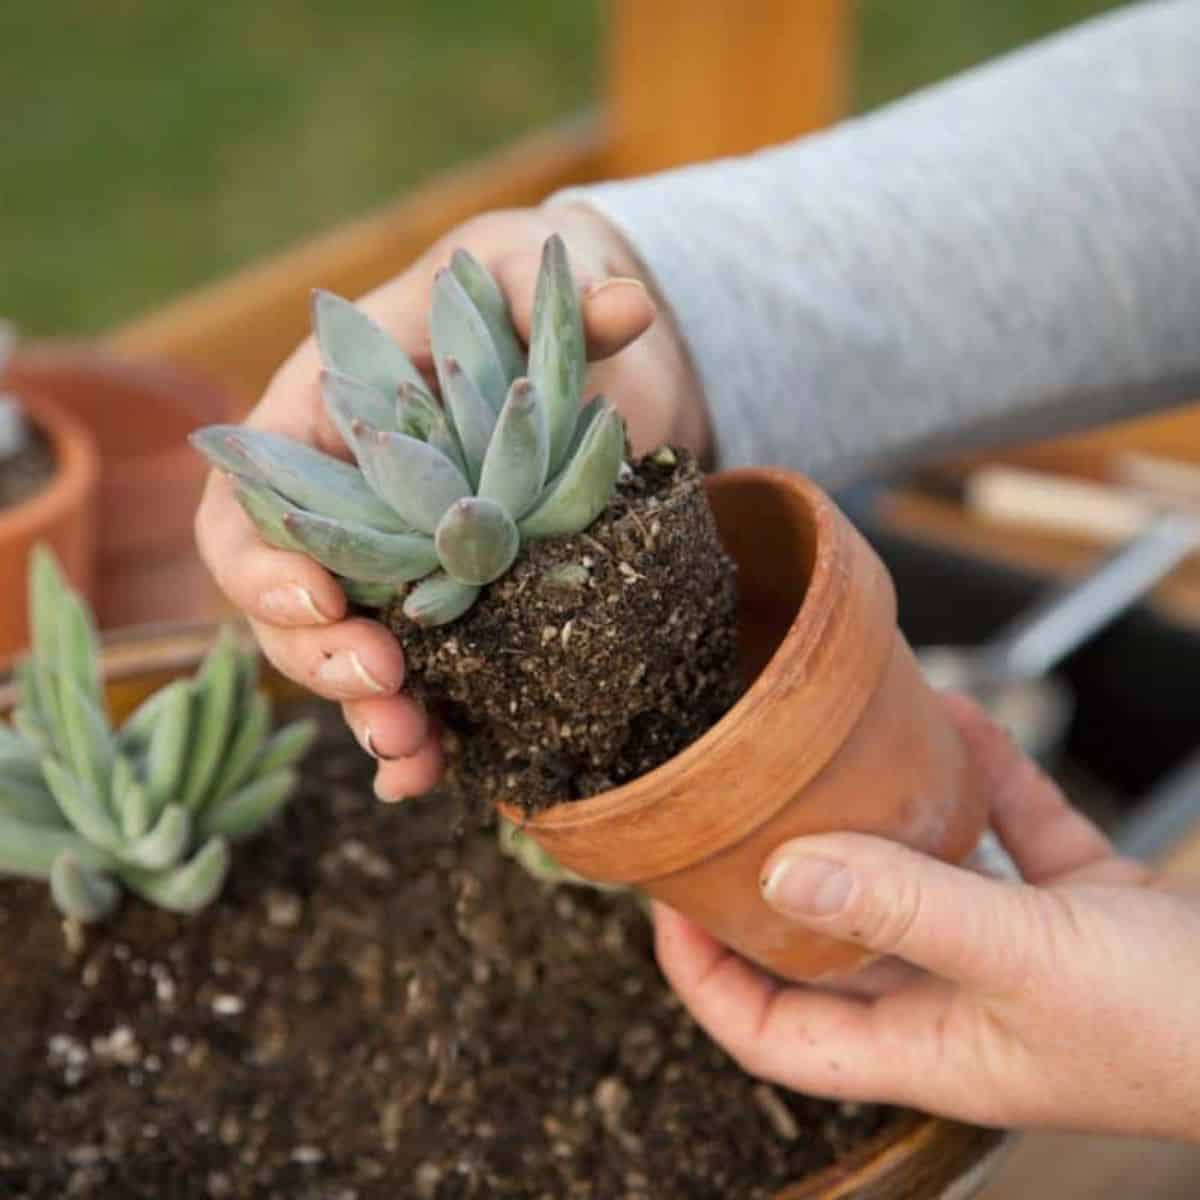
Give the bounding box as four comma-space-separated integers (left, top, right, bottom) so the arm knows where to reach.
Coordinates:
654, 904, 896, 1099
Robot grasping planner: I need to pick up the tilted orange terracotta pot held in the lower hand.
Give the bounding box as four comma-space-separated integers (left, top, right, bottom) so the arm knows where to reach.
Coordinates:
505, 469, 986, 980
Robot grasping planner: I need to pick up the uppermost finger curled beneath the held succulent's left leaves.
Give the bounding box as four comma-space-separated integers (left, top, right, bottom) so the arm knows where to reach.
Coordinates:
196, 472, 346, 626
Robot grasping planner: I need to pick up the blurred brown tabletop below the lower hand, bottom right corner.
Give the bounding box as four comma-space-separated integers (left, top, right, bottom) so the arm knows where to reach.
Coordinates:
978, 824, 1200, 1200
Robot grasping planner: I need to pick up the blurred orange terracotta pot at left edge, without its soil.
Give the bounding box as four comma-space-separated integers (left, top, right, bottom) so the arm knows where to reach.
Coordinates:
0, 392, 98, 662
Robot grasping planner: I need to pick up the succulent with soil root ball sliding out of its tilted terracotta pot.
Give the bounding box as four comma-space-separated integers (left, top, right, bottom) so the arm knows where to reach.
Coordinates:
193, 239, 985, 978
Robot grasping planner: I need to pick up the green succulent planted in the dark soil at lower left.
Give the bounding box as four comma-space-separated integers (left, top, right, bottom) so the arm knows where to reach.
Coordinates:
0, 547, 316, 922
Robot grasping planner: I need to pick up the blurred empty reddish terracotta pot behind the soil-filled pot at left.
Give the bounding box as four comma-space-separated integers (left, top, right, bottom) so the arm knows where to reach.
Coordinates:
6, 342, 232, 628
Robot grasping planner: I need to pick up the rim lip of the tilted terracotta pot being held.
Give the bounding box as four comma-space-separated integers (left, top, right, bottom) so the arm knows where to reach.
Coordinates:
497, 467, 883, 835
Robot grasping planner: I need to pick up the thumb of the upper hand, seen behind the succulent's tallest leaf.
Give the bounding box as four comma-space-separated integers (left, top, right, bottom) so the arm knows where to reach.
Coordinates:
494, 252, 655, 360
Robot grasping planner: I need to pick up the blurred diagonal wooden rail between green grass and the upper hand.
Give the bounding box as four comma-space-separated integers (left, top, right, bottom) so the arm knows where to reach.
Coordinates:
113, 116, 605, 406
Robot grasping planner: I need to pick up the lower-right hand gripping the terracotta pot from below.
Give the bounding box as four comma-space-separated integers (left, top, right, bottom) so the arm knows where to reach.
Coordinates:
655, 697, 1200, 1139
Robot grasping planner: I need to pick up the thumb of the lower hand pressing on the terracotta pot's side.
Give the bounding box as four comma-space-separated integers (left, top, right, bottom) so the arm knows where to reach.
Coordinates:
762, 833, 1074, 992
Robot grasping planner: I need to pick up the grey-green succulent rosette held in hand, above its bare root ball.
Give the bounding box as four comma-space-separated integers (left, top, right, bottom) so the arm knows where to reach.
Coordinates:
192, 236, 625, 625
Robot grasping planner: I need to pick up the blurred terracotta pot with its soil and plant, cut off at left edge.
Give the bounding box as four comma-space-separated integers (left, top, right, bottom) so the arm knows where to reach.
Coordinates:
0, 324, 97, 662
